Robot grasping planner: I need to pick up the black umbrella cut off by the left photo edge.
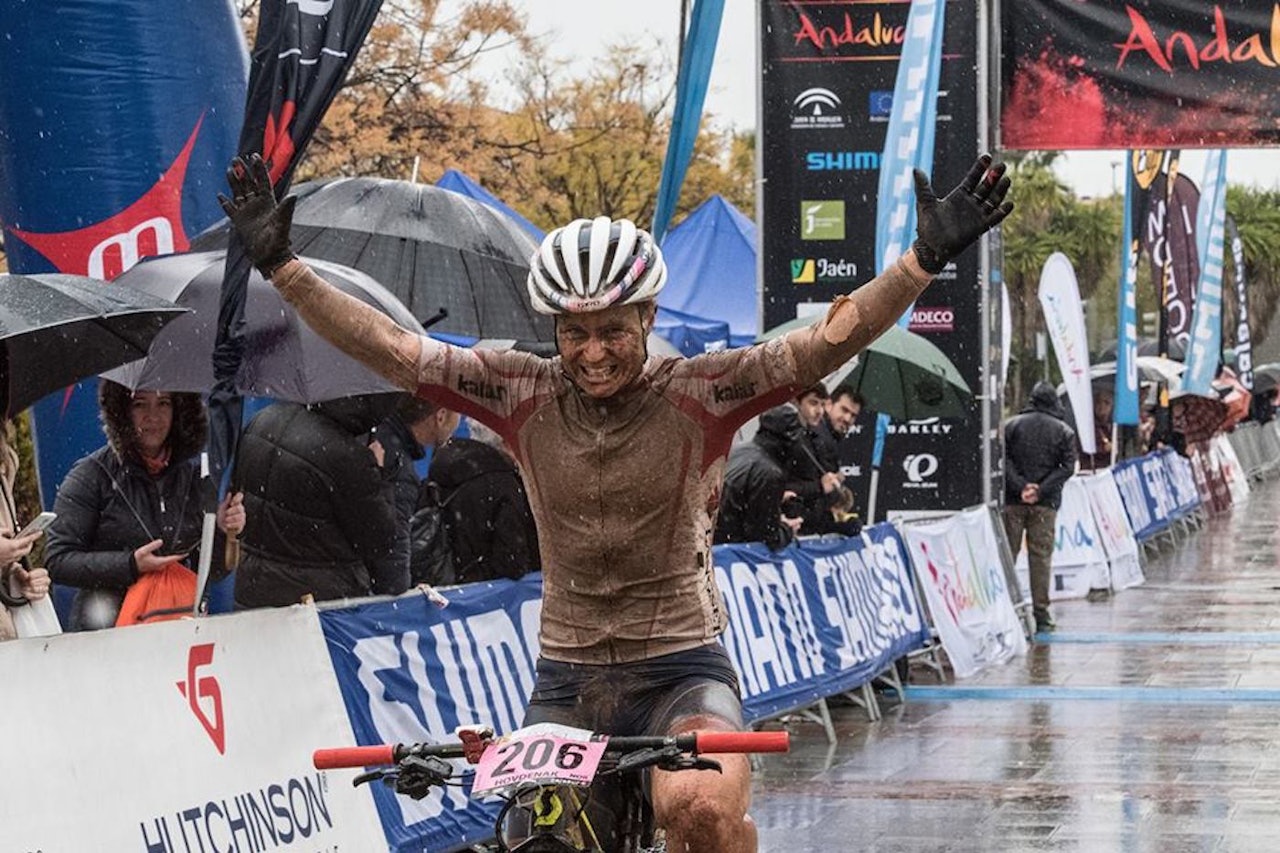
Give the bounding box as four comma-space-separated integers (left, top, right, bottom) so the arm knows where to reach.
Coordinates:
0, 273, 186, 418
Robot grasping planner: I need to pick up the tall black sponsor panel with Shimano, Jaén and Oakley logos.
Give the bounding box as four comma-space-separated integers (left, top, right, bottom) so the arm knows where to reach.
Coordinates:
759, 0, 984, 516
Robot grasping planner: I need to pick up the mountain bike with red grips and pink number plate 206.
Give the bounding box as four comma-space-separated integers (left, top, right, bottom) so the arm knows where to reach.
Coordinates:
312, 724, 790, 853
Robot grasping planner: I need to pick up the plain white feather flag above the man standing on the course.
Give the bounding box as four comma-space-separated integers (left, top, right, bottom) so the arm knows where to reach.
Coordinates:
1039, 252, 1097, 453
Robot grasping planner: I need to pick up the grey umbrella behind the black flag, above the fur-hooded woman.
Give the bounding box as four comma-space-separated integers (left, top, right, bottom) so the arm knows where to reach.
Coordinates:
104, 252, 424, 403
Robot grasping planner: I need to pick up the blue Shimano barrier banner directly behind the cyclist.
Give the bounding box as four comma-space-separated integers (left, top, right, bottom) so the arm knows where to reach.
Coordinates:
320, 525, 928, 850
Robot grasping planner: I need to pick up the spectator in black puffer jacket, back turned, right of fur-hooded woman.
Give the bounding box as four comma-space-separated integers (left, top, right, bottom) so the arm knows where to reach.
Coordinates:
232, 394, 408, 608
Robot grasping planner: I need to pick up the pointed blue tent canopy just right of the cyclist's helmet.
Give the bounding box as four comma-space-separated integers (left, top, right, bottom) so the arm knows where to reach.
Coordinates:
658, 196, 760, 346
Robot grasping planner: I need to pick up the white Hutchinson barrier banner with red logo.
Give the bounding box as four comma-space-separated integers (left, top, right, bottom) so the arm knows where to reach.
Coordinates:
0, 607, 385, 853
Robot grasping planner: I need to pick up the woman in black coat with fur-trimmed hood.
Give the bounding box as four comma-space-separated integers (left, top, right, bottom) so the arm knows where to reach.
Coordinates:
45, 379, 244, 630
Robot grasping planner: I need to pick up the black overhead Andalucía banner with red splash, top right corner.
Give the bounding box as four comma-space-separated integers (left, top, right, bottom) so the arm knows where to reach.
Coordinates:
1000, 0, 1280, 150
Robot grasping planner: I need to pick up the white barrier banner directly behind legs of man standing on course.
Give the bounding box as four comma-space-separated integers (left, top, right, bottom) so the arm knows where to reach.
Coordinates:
1009, 476, 1111, 601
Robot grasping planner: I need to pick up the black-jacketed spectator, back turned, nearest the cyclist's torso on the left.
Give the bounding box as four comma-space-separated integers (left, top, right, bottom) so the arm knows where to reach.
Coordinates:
419, 421, 541, 584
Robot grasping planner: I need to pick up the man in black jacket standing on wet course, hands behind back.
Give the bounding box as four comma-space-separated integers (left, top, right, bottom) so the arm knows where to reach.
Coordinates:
1005, 382, 1075, 631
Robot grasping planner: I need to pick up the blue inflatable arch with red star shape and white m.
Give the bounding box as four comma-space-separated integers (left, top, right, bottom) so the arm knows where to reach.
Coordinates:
0, 0, 248, 505
